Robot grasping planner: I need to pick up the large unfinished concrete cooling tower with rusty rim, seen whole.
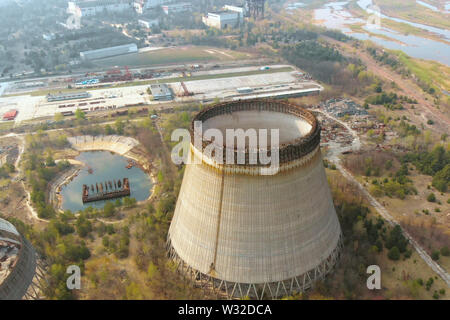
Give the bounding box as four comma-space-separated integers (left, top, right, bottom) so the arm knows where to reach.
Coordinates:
167, 100, 342, 299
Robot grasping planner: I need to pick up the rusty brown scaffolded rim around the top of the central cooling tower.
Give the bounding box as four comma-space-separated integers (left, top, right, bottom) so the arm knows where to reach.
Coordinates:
190, 99, 321, 166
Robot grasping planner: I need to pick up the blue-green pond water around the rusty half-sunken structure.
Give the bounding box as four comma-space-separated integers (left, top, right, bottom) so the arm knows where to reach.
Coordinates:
61, 151, 152, 212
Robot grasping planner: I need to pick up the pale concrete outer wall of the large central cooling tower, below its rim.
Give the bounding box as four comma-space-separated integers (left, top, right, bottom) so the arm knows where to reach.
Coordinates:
169, 146, 341, 283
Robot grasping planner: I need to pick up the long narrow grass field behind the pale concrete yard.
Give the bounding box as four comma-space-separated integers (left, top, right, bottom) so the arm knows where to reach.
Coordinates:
93, 46, 251, 67
